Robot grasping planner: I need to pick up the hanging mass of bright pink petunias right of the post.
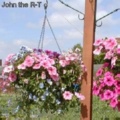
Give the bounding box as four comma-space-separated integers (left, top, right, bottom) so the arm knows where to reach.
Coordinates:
93, 38, 120, 111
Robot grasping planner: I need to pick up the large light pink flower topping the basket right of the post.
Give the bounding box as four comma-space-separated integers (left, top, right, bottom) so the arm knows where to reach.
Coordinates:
104, 38, 117, 50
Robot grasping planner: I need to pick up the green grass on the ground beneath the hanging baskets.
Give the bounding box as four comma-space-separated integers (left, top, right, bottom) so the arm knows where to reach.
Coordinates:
0, 94, 120, 120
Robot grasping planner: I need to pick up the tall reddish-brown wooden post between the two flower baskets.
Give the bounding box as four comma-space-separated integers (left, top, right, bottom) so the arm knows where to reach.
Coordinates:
80, 0, 97, 120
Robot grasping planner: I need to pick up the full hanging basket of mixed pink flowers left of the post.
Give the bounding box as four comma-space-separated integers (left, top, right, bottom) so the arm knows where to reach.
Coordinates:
1, 47, 84, 112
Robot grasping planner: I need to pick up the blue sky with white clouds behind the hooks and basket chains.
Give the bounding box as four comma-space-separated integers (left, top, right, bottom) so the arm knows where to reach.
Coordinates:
0, 0, 120, 60
